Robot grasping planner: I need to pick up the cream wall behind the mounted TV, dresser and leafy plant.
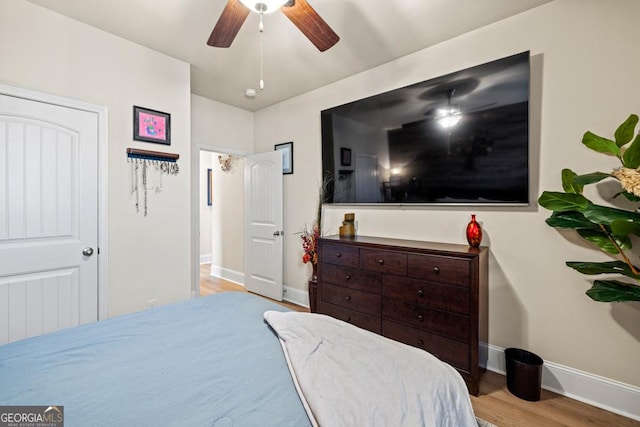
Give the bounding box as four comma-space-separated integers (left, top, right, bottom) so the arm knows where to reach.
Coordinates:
255, 0, 640, 392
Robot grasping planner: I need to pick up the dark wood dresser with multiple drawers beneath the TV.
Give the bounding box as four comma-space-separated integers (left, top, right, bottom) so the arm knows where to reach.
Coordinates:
316, 236, 488, 395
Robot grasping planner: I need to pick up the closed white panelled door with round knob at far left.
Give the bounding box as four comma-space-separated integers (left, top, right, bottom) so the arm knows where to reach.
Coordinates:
0, 94, 98, 344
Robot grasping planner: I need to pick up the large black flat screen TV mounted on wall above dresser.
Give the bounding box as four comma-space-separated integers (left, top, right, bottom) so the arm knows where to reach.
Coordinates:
321, 52, 530, 205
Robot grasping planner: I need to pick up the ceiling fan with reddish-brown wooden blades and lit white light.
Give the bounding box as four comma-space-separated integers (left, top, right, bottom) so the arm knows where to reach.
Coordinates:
207, 0, 340, 52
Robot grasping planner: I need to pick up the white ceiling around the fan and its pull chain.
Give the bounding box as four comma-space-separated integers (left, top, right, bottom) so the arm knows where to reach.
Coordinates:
28, 0, 552, 111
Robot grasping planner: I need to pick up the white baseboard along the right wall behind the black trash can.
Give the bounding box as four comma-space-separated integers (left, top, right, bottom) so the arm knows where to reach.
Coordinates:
487, 344, 640, 421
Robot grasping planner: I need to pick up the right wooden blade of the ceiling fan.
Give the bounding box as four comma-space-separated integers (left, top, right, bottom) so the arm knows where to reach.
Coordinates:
280, 0, 340, 52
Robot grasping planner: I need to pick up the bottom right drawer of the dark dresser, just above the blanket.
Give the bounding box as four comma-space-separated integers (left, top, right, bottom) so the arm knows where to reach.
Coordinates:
382, 320, 469, 371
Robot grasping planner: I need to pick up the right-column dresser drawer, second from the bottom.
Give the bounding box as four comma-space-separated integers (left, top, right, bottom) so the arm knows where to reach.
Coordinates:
382, 298, 469, 341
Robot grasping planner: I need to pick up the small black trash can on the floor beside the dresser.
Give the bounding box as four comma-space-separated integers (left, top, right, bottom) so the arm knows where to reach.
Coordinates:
504, 348, 544, 402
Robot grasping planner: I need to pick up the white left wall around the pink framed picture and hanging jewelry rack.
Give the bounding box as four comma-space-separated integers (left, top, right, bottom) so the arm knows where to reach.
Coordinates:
0, 0, 191, 316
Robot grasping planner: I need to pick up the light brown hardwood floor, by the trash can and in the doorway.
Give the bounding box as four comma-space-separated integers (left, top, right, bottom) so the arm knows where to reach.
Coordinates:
200, 264, 640, 427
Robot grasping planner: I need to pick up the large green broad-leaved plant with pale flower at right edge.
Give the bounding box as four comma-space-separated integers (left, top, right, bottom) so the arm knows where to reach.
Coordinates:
538, 114, 640, 302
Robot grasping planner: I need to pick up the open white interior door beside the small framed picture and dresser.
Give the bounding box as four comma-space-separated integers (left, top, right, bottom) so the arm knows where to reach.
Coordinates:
244, 151, 283, 301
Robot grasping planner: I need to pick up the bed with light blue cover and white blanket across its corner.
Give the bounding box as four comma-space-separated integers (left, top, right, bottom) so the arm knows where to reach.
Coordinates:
0, 292, 477, 427
